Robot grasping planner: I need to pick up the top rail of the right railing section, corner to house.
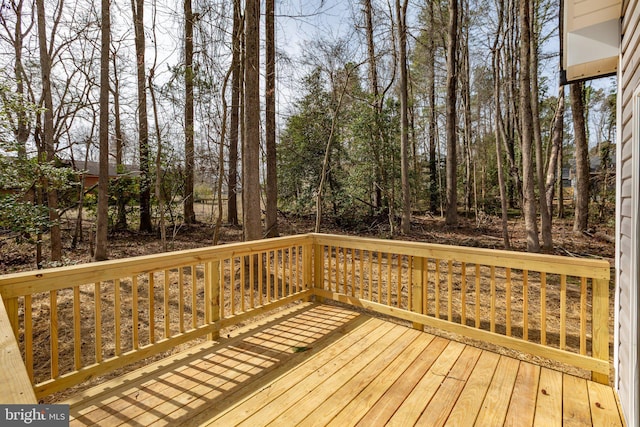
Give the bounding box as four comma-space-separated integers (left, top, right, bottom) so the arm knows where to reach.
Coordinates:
312, 234, 611, 280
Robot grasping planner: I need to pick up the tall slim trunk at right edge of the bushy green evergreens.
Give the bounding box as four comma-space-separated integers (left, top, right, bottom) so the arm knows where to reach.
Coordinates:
396, 0, 411, 234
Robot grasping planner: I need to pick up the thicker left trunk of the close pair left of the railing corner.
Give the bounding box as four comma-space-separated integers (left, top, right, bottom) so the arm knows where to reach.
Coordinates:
242, 0, 262, 241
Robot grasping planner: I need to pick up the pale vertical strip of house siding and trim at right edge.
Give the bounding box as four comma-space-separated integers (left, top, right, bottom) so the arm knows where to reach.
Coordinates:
615, 1, 640, 426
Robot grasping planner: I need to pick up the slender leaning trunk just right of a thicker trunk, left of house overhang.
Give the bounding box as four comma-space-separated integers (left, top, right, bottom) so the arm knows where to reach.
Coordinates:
529, 2, 553, 252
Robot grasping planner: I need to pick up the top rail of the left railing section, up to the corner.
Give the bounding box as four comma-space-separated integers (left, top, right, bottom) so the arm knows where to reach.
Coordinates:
0, 234, 311, 298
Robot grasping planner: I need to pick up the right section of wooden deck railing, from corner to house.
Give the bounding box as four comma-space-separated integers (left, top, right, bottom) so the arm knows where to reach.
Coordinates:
314, 235, 610, 383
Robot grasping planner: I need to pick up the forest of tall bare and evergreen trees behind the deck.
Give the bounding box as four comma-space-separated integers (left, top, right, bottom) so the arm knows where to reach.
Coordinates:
0, 0, 616, 268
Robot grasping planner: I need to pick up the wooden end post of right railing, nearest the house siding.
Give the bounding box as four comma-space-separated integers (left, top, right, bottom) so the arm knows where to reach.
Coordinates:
591, 278, 609, 384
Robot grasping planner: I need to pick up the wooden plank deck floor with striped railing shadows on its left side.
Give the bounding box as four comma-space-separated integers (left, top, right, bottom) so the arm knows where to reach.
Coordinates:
66, 303, 623, 426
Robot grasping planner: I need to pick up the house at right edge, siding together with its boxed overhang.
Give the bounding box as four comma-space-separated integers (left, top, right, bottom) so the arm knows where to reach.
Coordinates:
560, 0, 640, 426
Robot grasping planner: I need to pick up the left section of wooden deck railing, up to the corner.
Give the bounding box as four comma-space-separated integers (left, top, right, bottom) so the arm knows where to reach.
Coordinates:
0, 236, 312, 398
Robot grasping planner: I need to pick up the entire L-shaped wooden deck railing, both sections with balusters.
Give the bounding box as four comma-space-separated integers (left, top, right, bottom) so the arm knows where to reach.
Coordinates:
0, 234, 609, 398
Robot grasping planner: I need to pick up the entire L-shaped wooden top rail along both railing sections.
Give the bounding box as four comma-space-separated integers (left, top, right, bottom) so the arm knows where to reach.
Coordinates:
0, 233, 610, 298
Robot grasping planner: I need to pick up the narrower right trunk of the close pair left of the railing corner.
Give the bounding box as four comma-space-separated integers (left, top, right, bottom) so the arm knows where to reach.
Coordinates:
265, 0, 278, 237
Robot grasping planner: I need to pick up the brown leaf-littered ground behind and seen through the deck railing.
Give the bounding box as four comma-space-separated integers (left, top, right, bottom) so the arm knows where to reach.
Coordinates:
0, 217, 614, 402
